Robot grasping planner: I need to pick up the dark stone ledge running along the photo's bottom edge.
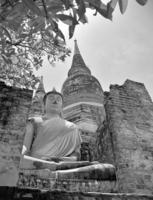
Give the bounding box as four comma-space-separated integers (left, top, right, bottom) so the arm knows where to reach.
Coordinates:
0, 187, 153, 200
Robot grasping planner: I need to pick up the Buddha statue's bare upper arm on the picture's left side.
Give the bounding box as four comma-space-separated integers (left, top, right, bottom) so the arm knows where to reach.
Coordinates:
22, 121, 34, 155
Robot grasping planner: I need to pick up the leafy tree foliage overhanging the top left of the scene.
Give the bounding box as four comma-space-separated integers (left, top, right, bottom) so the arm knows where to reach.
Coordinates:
0, 0, 147, 88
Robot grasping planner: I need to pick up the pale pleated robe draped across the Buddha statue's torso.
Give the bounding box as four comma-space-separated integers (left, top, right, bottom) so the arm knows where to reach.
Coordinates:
31, 117, 81, 159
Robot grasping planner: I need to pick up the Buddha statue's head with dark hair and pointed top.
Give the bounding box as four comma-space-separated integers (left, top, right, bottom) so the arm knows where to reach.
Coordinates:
43, 88, 63, 116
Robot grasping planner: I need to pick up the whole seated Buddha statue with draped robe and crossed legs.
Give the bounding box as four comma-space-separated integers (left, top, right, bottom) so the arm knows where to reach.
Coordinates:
20, 90, 116, 180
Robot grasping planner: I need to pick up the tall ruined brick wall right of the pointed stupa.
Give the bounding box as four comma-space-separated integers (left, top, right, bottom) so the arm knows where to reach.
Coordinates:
105, 80, 153, 194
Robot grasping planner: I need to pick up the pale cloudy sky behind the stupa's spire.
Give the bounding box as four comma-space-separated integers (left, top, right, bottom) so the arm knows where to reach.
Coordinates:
38, 0, 153, 99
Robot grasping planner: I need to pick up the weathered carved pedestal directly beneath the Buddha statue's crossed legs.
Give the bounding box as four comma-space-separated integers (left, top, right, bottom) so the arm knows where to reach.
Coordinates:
18, 170, 117, 192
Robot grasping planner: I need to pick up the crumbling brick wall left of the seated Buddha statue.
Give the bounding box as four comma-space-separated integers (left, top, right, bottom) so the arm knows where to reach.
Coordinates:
0, 82, 32, 186
